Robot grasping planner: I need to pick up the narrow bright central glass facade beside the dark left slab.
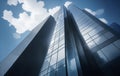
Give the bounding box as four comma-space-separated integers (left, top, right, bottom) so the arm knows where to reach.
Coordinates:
39, 9, 66, 76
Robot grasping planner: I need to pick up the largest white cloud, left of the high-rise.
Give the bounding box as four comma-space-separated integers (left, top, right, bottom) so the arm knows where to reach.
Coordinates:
2, 0, 49, 34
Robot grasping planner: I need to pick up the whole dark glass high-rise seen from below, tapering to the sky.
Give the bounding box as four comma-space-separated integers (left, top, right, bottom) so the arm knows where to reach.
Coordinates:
0, 5, 120, 76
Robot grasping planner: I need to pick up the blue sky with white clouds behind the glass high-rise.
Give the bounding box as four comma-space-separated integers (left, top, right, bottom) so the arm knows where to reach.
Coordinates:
0, 0, 120, 62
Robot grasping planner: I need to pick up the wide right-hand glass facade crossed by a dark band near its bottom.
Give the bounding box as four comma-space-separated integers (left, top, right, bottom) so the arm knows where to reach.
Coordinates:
69, 6, 120, 66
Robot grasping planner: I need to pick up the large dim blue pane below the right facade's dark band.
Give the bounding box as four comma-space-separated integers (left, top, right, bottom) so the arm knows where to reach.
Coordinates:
102, 44, 120, 60
